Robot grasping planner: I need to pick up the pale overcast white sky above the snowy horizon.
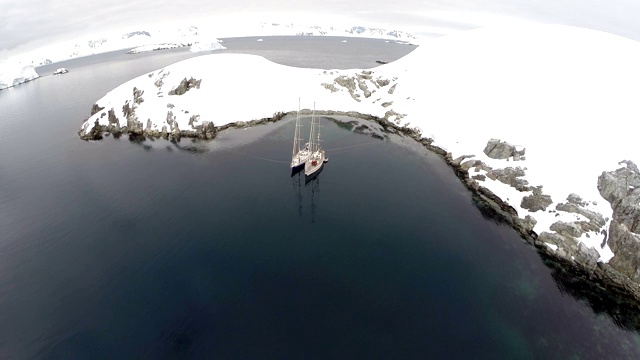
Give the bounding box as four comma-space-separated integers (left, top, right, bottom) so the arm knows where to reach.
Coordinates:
0, 0, 640, 59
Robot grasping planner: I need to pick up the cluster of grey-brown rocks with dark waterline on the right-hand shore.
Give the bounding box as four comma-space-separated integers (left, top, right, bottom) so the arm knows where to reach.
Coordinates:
456, 139, 640, 310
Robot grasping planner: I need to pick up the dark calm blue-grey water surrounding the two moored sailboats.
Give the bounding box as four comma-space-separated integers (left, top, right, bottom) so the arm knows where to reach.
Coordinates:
0, 38, 640, 359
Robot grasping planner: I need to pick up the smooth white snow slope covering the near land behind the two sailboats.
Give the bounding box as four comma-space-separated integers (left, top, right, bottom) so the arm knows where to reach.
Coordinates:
80, 24, 640, 262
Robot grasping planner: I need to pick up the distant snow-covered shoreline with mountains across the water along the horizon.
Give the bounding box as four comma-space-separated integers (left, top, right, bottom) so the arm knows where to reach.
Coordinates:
0, 22, 418, 90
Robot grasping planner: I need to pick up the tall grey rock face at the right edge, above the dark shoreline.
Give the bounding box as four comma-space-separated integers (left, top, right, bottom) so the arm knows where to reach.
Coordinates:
598, 160, 640, 283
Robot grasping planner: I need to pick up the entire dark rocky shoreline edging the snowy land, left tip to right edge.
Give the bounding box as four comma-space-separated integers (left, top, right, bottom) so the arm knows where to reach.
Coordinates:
79, 107, 640, 324
